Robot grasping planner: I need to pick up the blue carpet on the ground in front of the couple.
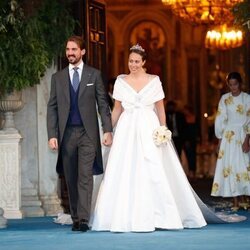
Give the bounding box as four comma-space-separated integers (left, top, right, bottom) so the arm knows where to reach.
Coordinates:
0, 211, 250, 250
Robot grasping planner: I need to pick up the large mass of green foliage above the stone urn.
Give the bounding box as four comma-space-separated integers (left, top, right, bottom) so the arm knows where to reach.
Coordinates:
0, 0, 76, 95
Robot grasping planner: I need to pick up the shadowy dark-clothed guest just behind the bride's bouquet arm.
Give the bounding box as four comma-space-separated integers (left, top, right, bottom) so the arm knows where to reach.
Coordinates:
166, 101, 186, 159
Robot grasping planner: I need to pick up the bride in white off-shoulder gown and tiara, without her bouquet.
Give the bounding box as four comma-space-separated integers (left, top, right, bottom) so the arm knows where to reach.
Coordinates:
92, 45, 244, 232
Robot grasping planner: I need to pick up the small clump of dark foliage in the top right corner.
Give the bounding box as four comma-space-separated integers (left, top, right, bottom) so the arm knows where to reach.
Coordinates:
232, 0, 250, 33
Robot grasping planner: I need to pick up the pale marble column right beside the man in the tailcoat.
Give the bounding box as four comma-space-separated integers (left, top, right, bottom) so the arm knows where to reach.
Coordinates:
37, 66, 63, 216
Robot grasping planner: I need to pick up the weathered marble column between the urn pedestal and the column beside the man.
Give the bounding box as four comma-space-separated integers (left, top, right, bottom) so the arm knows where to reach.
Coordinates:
15, 87, 44, 217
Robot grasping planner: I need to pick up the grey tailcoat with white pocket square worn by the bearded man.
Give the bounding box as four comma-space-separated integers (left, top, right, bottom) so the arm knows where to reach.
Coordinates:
47, 64, 112, 174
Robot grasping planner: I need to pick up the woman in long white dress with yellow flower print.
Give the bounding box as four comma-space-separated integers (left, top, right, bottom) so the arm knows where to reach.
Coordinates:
211, 72, 250, 211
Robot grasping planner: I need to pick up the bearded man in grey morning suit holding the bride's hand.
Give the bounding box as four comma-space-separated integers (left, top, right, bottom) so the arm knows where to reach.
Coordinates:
47, 36, 112, 232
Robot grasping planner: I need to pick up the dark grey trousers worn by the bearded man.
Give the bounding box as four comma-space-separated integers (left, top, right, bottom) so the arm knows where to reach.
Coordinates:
61, 126, 96, 221
